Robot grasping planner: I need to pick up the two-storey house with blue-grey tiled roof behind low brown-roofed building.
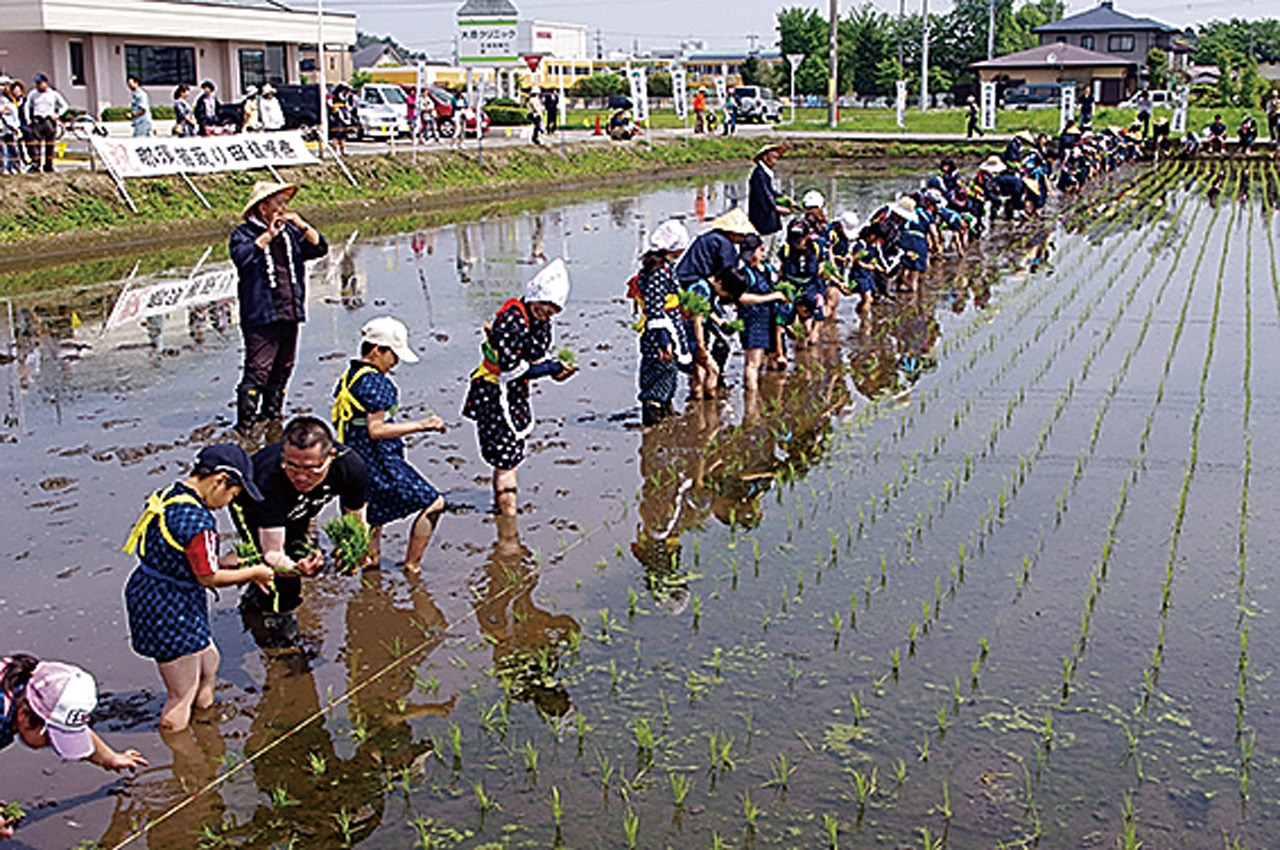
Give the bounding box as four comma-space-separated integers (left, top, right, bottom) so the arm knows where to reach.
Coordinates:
1032, 0, 1190, 73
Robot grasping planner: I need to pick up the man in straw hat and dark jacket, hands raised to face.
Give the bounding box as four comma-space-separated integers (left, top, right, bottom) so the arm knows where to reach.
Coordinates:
230, 182, 329, 435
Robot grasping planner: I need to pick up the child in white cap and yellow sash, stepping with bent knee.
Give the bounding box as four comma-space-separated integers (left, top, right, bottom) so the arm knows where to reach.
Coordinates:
333, 316, 444, 573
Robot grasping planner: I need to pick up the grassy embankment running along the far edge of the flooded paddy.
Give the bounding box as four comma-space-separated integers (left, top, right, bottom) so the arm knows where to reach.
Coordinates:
0, 137, 988, 265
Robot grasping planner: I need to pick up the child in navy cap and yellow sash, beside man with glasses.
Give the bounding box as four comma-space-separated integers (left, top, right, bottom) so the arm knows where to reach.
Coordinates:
124, 443, 274, 732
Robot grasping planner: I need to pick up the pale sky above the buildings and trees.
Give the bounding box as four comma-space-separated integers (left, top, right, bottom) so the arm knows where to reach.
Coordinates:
327, 0, 1259, 59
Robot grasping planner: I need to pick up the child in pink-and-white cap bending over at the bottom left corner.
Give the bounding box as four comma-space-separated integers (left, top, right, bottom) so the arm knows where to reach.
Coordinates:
0, 653, 147, 838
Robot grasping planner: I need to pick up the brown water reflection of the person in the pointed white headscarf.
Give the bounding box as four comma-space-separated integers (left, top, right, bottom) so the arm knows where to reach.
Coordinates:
471, 516, 581, 723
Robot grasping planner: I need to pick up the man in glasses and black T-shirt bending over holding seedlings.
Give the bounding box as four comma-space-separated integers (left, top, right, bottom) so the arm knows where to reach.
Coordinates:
230, 416, 369, 613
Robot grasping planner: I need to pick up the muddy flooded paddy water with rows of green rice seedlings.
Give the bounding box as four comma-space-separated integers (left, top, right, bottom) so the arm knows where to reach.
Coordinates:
0, 166, 1280, 847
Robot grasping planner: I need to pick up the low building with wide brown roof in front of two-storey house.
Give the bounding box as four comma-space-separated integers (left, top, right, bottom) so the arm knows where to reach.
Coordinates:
969, 41, 1138, 105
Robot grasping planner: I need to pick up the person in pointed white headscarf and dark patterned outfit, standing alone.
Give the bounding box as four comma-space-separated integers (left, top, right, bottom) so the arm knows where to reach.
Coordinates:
462, 260, 577, 516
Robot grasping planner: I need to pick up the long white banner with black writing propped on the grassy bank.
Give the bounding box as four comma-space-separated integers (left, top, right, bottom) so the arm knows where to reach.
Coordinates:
90, 129, 320, 178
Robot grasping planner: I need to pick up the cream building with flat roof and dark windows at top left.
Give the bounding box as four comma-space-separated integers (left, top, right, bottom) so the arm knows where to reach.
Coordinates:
0, 0, 356, 115
